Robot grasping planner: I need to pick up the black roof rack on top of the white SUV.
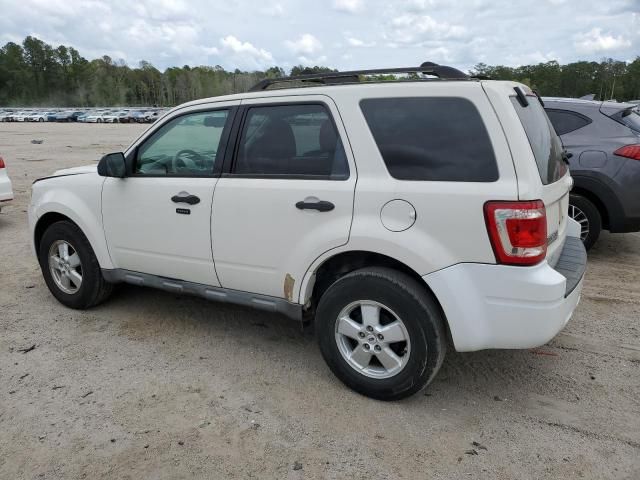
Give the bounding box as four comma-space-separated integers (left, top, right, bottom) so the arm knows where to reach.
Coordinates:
249, 62, 470, 92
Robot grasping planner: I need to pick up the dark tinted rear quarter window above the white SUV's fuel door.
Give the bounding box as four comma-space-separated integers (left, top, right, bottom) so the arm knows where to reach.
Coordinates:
360, 97, 498, 182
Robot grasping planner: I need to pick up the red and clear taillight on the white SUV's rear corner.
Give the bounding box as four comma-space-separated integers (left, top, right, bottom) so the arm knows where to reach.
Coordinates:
484, 200, 547, 265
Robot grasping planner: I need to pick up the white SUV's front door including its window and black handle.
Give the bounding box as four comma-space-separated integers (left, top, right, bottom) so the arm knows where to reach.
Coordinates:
102, 102, 239, 286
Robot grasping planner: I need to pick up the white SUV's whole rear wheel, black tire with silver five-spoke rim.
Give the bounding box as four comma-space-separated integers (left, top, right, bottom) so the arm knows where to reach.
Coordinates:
316, 268, 446, 400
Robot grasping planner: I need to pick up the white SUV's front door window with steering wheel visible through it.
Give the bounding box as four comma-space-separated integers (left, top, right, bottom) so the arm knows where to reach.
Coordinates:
134, 110, 229, 176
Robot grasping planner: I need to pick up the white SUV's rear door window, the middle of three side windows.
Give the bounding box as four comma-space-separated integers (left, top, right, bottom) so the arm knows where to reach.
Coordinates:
233, 104, 349, 180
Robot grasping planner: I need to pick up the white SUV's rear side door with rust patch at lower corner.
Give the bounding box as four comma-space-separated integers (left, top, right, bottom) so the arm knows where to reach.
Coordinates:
211, 96, 356, 302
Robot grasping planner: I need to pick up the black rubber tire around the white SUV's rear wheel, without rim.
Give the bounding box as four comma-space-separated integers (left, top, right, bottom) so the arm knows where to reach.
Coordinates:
315, 267, 446, 400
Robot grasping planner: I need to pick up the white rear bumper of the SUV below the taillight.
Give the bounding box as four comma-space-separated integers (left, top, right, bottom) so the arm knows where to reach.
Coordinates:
423, 231, 586, 352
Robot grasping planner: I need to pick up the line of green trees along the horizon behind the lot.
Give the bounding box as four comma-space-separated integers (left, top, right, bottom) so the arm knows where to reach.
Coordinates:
0, 36, 640, 107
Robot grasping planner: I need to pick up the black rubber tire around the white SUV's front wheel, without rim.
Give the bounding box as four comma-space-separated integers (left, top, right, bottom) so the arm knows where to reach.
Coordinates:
38, 221, 113, 309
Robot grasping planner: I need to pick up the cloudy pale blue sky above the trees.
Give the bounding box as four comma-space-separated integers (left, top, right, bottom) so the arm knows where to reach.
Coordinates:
0, 0, 640, 71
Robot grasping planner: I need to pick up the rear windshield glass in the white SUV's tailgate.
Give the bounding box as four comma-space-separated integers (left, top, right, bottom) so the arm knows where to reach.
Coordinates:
511, 97, 567, 185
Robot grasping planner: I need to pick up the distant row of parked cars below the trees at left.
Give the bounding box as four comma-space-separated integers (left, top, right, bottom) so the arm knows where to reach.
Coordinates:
0, 108, 165, 123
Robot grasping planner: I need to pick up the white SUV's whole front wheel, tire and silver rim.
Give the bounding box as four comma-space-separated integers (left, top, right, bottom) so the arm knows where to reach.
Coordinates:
38, 221, 113, 309
